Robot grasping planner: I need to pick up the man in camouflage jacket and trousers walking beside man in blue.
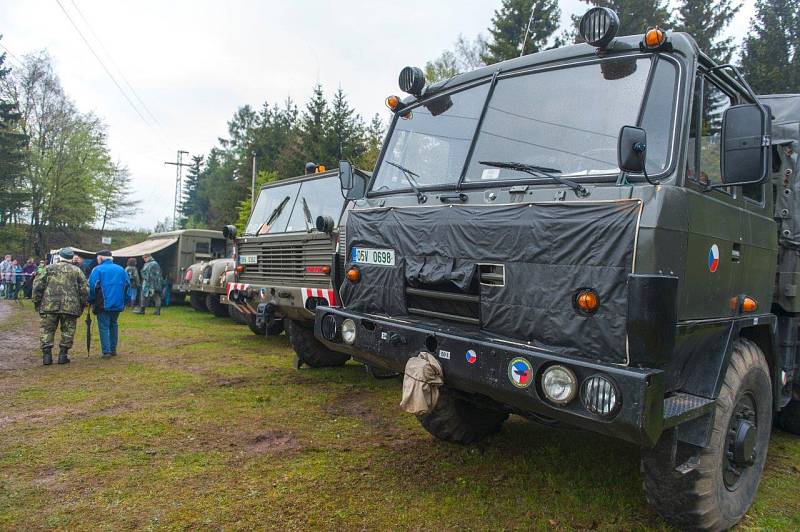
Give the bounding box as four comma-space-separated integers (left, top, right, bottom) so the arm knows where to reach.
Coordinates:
33, 248, 89, 366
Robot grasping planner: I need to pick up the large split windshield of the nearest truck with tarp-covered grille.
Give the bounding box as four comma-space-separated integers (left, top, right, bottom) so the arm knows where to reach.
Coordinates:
372, 57, 677, 192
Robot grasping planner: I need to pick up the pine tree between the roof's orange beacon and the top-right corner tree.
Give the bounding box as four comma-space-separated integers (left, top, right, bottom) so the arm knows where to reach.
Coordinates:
675, 0, 741, 63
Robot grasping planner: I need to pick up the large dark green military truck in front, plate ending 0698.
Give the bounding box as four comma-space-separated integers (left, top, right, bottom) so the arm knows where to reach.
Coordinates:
315, 8, 800, 529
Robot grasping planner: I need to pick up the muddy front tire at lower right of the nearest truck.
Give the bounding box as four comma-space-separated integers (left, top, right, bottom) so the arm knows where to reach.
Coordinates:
641, 339, 772, 530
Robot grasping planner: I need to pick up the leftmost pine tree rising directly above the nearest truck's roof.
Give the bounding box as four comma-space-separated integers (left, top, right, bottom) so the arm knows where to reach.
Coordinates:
481, 0, 561, 65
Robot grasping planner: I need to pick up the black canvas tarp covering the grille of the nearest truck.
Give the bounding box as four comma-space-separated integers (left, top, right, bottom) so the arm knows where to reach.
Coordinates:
342, 200, 641, 363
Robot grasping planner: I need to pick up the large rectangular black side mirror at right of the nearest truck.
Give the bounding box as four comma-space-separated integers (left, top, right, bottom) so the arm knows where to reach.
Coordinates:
720, 104, 769, 185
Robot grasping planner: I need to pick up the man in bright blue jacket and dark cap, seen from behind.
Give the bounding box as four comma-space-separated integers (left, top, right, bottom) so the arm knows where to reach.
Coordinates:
89, 249, 128, 358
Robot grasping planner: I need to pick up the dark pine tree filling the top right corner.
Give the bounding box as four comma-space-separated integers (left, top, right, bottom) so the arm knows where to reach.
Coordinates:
741, 0, 800, 94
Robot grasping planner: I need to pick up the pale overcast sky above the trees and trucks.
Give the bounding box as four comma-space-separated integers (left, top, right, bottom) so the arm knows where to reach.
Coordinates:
0, 0, 753, 229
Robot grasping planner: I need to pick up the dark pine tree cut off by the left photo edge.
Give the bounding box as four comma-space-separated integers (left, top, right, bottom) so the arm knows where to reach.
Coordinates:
0, 36, 28, 226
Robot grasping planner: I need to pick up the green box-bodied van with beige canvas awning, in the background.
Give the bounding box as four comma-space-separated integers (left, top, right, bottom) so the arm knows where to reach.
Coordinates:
113, 229, 227, 301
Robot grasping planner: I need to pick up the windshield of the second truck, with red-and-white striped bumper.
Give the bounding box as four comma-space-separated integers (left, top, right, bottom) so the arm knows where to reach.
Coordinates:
245, 175, 344, 236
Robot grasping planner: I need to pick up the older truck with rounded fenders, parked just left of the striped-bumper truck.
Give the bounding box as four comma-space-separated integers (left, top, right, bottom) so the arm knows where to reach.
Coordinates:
184, 258, 236, 317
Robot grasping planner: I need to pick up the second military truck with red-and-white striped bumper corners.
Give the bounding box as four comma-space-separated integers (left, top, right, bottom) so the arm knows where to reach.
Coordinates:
225, 171, 366, 367
